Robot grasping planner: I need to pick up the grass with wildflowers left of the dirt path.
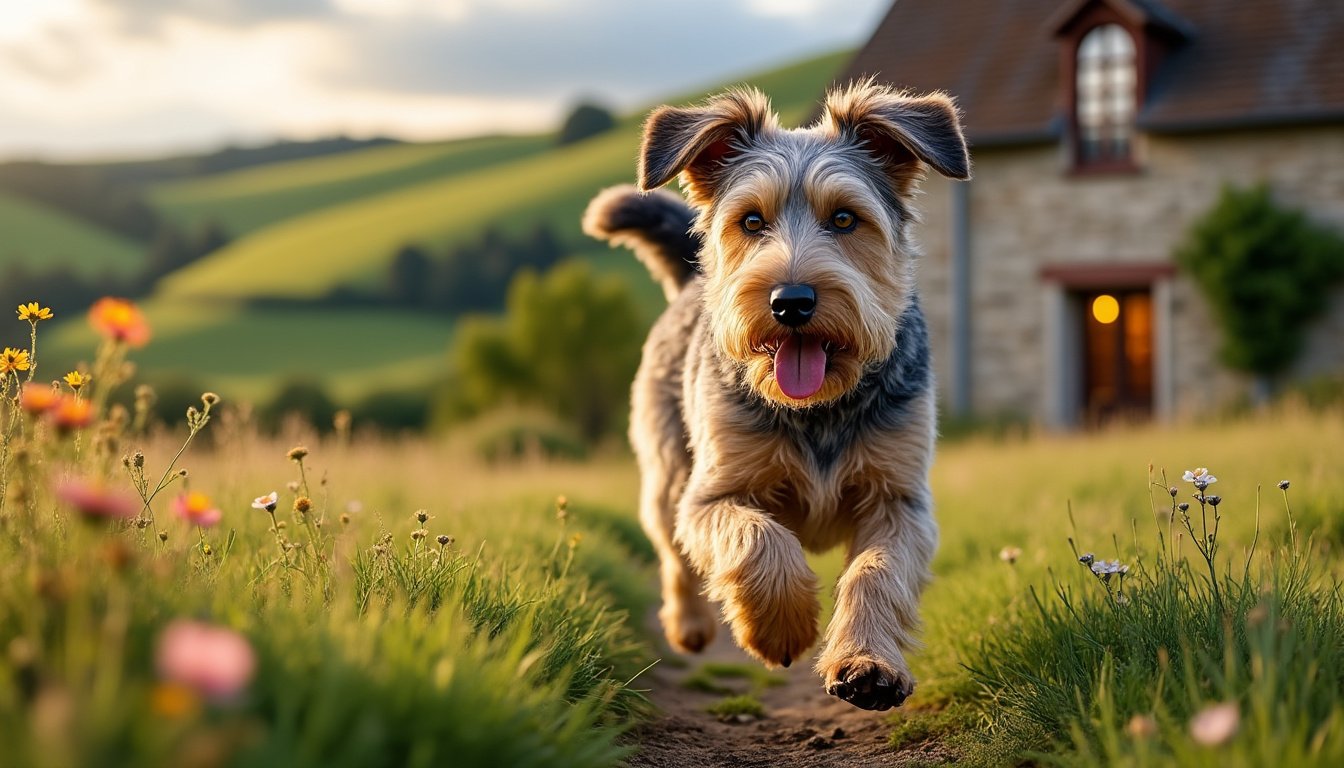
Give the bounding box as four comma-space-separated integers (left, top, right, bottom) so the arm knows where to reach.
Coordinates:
0, 312, 653, 767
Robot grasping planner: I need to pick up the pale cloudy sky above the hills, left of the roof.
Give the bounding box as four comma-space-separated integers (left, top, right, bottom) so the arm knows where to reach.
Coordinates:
0, 0, 890, 159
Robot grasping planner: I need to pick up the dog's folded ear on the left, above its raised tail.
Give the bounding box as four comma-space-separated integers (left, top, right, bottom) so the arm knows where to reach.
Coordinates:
638, 89, 778, 204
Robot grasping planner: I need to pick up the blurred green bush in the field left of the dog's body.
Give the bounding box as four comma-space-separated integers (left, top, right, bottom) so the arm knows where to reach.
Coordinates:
452, 261, 644, 440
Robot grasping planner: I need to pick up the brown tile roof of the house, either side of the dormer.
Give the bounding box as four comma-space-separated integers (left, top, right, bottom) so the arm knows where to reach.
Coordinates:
847, 0, 1344, 145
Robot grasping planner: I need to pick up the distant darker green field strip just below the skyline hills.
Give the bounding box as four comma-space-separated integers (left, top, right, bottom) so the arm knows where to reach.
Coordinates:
149, 136, 552, 238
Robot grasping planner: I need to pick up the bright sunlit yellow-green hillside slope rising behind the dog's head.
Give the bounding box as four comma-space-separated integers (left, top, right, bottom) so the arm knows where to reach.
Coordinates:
160, 47, 847, 306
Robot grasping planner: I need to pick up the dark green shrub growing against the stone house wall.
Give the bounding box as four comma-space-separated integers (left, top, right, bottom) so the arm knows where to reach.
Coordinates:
1175, 184, 1344, 377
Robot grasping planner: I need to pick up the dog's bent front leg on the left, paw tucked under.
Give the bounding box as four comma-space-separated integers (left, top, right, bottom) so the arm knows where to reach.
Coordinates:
676, 486, 820, 667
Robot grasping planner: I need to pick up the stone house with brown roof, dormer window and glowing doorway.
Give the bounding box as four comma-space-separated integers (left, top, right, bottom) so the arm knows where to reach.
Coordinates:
843, 0, 1344, 426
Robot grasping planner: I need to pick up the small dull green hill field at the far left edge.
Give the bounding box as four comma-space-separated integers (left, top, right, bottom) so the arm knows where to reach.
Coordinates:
0, 194, 145, 278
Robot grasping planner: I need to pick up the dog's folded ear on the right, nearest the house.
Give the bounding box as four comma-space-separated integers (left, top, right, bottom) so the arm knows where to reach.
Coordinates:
821, 81, 970, 180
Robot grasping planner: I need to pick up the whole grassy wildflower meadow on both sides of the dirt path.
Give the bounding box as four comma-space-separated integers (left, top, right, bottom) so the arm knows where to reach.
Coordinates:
0, 307, 1344, 765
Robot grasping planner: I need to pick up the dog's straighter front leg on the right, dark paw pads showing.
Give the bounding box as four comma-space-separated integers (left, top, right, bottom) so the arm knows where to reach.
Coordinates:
817, 488, 938, 710
